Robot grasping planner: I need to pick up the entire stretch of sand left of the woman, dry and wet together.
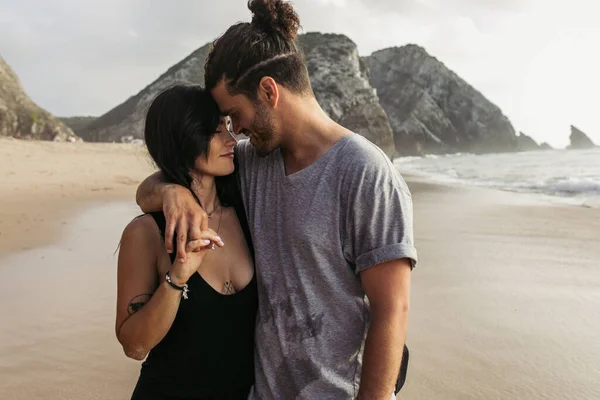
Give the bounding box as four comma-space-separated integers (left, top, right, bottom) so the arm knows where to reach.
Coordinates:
0, 138, 153, 400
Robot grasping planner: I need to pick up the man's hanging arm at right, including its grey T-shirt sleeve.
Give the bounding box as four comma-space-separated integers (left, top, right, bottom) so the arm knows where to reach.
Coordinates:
343, 146, 417, 400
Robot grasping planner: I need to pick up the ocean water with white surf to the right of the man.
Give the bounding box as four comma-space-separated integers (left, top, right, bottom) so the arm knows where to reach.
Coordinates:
394, 148, 600, 208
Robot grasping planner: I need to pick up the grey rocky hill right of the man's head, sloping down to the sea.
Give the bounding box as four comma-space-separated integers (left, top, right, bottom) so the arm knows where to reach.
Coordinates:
364, 45, 518, 155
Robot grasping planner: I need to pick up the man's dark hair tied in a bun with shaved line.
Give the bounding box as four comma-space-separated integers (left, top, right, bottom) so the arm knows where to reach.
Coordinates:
204, 0, 312, 99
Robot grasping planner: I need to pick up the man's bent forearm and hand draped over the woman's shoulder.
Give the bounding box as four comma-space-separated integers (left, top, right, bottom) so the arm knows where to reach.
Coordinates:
135, 172, 208, 262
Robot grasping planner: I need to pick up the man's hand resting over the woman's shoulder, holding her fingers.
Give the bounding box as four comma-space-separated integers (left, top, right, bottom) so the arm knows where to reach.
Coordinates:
162, 185, 208, 263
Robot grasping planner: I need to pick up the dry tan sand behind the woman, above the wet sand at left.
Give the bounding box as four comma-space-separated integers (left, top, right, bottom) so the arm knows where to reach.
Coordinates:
0, 138, 154, 256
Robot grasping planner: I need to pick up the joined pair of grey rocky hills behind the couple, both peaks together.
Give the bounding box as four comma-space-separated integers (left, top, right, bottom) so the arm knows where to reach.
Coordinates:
55, 33, 537, 156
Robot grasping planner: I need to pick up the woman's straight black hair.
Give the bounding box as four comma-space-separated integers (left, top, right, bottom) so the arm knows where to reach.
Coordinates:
144, 85, 237, 206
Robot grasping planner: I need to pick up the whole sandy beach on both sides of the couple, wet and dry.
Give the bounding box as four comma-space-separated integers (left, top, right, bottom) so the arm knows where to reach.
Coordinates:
0, 139, 600, 400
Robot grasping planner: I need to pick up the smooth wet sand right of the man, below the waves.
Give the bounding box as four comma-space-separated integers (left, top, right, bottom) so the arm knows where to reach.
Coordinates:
399, 184, 600, 400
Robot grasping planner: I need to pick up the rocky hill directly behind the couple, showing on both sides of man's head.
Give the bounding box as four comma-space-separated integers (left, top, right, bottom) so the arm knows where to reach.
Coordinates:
79, 33, 394, 156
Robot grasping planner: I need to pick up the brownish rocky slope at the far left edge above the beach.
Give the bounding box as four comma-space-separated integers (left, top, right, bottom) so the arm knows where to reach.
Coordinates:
0, 56, 79, 141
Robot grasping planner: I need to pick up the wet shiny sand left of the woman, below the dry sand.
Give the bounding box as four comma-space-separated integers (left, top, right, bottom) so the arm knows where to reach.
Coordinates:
0, 203, 139, 400
